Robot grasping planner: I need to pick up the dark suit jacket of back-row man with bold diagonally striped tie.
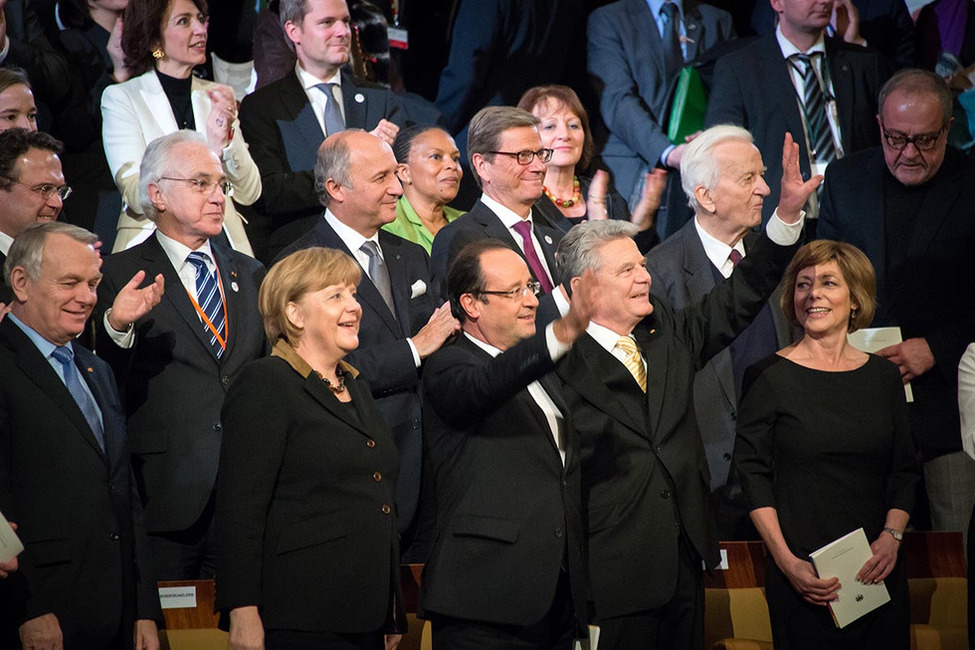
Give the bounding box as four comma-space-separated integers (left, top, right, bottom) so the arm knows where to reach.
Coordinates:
704, 33, 890, 223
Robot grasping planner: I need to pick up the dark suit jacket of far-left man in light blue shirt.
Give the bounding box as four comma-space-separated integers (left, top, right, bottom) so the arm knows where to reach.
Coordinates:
0, 317, 162, 648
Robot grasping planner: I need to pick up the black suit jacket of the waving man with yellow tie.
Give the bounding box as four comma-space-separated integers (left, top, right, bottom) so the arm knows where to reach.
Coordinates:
557, 233, 796, 622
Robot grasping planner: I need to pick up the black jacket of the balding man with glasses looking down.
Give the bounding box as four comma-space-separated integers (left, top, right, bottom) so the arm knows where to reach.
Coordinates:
819, 147, 975, 459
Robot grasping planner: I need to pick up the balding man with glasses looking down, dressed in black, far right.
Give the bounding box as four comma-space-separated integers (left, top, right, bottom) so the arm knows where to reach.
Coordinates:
819, 70, 975, 531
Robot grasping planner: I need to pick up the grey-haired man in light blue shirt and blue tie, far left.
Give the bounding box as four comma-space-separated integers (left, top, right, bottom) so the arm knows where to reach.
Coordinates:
0, 223, 162, 650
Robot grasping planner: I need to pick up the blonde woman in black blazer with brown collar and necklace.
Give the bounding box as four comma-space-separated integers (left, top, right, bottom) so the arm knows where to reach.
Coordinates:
216, 248, 405, 650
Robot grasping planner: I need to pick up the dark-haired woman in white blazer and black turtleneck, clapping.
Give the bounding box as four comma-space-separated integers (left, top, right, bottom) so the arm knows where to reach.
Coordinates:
102, 0, 261, 255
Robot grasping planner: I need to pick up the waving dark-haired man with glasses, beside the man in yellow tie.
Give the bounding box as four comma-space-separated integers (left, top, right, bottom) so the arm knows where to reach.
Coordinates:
420, 239, 595, 650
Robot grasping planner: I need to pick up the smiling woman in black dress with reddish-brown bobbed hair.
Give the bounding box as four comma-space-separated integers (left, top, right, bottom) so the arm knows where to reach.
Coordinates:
735, 240, 920, 650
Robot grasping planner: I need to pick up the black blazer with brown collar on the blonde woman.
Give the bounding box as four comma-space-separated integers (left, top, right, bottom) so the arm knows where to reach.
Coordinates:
216, 342, 406, 633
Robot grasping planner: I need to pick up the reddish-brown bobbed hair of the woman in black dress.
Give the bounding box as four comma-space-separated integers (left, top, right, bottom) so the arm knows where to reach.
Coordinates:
779, 239, 877, 332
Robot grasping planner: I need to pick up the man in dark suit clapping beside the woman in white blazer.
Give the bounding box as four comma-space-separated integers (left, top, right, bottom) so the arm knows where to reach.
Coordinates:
240, 0, 402, 258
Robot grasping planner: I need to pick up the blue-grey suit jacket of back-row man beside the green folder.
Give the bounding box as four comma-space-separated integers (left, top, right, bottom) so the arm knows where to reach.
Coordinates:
587, 0, 735, 198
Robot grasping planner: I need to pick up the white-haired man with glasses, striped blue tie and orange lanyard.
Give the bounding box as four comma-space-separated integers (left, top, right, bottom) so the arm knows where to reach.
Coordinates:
94, 131, 266, 580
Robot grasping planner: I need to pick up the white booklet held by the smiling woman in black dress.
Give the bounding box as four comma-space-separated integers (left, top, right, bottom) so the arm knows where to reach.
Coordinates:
809, 528, 890, 627
